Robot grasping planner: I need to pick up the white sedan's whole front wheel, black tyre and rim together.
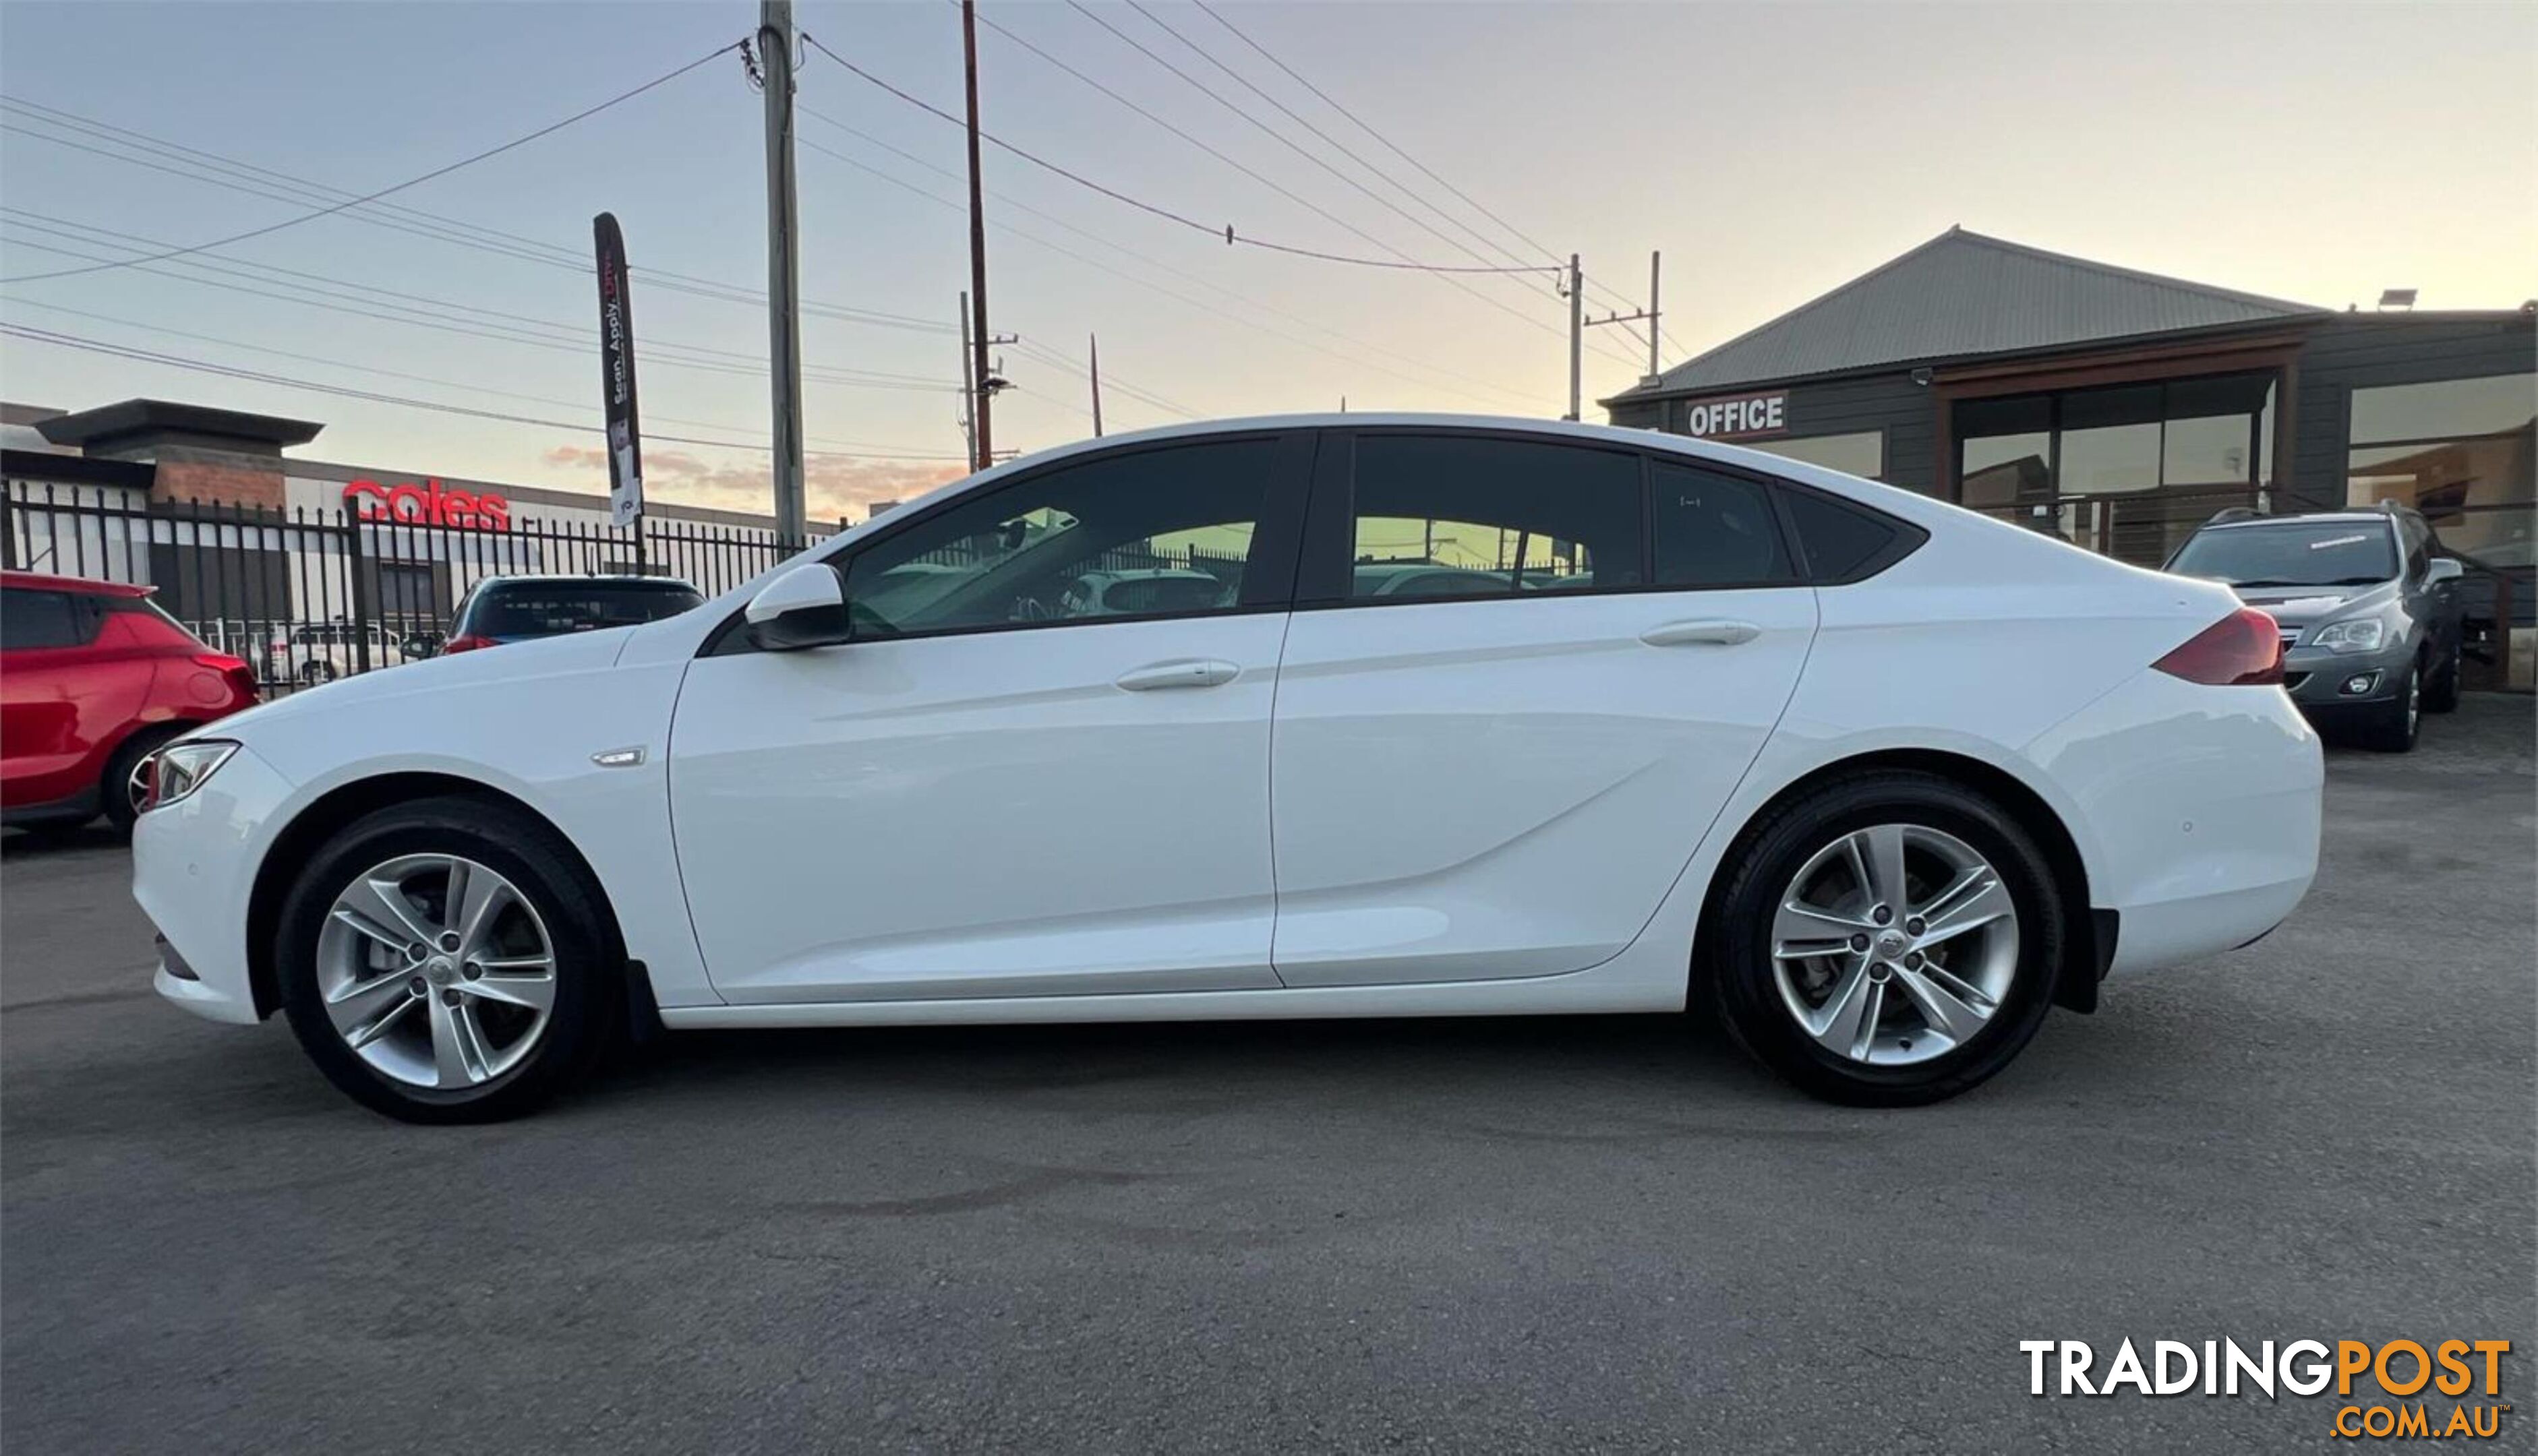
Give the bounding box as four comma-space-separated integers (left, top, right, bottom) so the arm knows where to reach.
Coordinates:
276, 799, 624, 1124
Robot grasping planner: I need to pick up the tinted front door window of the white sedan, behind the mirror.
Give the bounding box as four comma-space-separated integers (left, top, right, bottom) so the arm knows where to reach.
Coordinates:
845, 439, 1285, 637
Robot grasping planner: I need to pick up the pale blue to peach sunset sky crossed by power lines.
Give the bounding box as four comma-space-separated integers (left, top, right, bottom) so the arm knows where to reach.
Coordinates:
0, 0, 2538, 518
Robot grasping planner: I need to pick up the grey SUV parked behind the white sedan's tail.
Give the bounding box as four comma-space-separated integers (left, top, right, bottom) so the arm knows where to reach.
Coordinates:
2167, 502, 2462, 754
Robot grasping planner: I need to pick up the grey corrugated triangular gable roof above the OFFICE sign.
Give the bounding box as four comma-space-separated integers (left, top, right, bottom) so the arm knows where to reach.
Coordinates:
1607, 229, 2328, 403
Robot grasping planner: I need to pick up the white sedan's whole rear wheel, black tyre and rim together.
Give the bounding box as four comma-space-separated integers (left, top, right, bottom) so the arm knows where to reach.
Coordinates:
1701, 768, 2069, 1106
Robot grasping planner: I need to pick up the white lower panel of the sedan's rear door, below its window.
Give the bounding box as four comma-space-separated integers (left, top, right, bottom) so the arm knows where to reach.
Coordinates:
1272, 586, 1814, 987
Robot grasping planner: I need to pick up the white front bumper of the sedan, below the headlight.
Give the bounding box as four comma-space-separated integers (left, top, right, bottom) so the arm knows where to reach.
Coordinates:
132, 748, 289, 1025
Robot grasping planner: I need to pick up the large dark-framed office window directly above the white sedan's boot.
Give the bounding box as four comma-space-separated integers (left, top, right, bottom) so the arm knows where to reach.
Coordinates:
1952, 370, 2276, 566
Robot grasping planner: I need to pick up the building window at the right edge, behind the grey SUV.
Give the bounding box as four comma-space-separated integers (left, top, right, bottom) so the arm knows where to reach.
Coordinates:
2345, 373, 2538, 688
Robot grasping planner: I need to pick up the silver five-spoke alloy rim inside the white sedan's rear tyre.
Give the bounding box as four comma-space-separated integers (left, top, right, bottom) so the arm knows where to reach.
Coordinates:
1771, 824, 2017, 1065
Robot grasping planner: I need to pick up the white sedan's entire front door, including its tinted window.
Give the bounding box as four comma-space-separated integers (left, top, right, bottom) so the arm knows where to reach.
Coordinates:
670, 431, 1315, 1002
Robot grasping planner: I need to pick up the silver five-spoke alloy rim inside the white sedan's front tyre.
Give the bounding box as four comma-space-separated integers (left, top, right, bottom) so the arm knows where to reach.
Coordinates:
318, 855, 556, 1091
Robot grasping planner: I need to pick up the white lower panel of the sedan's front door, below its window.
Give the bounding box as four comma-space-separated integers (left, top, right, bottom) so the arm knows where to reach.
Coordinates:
670, 611, 1287, 1002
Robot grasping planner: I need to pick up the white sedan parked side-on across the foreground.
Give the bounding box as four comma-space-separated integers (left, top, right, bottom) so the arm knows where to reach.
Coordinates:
134, 413, 2322, 1121
